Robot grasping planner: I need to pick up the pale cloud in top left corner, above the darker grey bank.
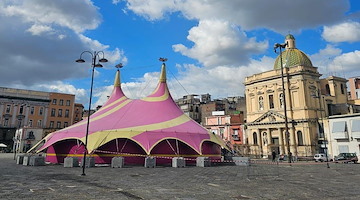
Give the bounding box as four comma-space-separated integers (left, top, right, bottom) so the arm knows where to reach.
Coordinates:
0, 0, 101, 32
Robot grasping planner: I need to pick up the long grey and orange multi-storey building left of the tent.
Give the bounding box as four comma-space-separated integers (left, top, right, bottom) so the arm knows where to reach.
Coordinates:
0, 87, 80, 151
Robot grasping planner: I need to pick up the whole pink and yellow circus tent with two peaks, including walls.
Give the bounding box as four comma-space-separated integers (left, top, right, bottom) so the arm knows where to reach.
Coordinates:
32, 64, 224, 163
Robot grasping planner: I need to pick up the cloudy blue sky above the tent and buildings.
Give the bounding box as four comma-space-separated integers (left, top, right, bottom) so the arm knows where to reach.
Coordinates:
0, 0, 360, 107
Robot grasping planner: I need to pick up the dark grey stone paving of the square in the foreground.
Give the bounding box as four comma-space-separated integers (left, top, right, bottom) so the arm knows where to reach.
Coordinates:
0, 153, 360, 200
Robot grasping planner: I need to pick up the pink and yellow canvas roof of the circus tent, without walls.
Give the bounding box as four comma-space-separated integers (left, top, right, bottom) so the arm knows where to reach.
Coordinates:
37, 64, 225, 155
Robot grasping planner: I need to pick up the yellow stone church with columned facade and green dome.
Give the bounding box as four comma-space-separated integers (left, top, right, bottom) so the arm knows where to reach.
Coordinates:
245, 34, 347, 157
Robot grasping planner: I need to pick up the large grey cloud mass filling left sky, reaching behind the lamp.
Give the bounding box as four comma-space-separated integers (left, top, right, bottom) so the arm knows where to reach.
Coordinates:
0, 0, 127, 89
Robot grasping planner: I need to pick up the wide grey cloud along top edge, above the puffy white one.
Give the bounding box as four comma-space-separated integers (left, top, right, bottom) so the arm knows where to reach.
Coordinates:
121, 0, 350, 33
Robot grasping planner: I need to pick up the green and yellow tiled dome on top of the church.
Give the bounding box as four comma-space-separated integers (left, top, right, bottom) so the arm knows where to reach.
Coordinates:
274, 48, 313, 69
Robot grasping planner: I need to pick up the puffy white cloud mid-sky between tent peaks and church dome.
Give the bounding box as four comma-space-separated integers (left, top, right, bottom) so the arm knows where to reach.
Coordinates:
173, 20, 268, 66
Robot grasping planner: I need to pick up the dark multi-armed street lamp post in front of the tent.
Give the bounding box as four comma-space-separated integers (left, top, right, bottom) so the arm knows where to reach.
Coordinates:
75, 51, 108, 176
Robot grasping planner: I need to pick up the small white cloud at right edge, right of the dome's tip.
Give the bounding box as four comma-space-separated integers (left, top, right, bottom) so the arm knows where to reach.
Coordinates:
322, 21, 360, 42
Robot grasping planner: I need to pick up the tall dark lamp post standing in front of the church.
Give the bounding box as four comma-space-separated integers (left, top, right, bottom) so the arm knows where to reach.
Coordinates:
274, 43, 292, 163
